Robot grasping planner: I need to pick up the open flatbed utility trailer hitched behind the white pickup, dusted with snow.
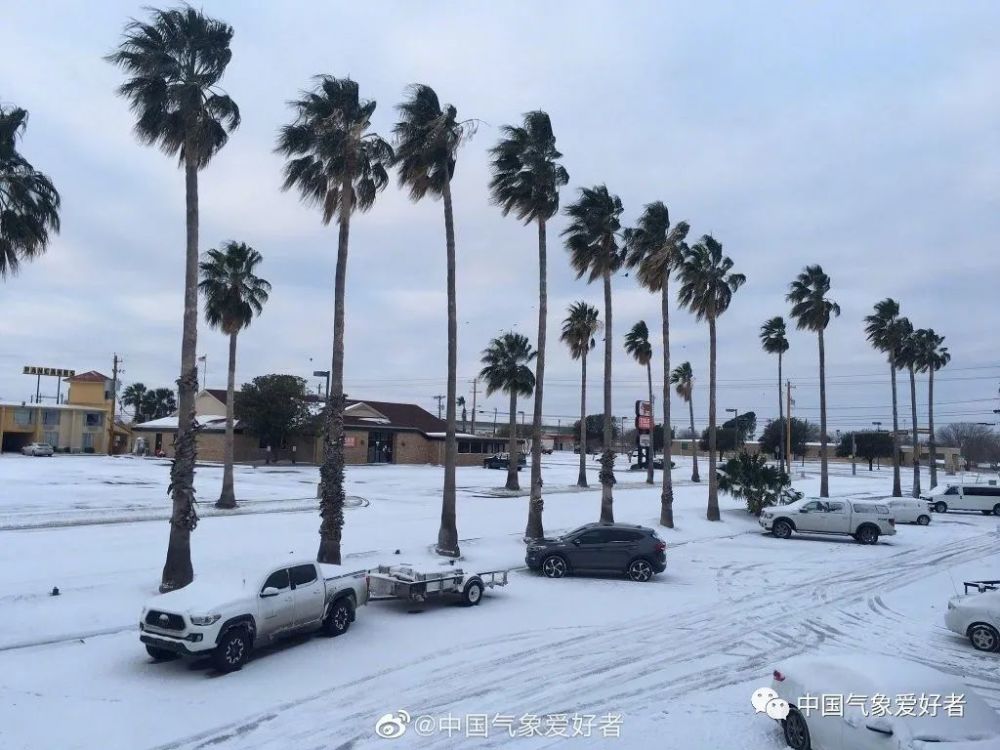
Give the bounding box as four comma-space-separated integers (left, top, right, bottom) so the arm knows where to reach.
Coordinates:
368, 564, 507, 607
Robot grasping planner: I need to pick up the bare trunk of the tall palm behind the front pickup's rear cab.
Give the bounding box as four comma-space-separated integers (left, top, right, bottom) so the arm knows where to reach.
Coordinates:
316, 180, 353, 565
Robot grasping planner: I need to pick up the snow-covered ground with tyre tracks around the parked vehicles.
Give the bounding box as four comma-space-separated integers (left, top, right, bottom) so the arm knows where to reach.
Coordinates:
0, 454, 1000, 750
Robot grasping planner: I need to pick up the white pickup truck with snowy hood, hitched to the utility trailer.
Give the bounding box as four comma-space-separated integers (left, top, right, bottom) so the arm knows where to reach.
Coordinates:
139, 561, 368, 672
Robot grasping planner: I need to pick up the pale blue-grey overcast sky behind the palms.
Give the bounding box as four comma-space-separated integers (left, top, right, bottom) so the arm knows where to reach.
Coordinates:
0, 0, 1000, 433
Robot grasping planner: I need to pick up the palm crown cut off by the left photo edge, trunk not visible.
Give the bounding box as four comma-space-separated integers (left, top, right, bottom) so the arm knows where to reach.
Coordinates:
0, 106, 59, 280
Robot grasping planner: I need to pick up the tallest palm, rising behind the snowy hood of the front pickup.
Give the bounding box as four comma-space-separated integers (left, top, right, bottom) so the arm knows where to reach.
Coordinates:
107, 5, 240, 591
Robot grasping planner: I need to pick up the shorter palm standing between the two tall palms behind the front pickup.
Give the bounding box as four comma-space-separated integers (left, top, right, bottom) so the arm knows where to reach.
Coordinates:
198, 241, 271, 508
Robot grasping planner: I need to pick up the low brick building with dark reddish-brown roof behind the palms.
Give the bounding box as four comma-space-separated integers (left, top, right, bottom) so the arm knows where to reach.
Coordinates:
130, 388, 507, 466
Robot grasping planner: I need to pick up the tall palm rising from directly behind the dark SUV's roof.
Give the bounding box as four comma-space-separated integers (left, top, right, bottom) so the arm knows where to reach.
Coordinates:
562, 185, 624, 523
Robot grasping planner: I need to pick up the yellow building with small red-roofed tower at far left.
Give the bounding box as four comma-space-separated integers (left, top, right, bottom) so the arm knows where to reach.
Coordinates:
0, 370, 126, 453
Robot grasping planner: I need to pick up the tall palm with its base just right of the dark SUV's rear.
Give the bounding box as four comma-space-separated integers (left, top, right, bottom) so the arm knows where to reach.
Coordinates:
625, 201, 690, 528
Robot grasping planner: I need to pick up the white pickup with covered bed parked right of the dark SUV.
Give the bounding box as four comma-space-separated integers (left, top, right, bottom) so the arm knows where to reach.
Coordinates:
760, 499, 896, 544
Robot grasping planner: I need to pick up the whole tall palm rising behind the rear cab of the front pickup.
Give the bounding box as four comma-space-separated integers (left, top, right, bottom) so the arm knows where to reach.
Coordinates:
275, 75, 393, 564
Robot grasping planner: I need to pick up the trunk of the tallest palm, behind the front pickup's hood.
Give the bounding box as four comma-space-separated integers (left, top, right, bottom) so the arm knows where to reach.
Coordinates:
160, 150, 198, 592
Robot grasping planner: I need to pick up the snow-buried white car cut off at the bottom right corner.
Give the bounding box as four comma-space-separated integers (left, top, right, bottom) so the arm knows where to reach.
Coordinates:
771, 654, 1000, 750
